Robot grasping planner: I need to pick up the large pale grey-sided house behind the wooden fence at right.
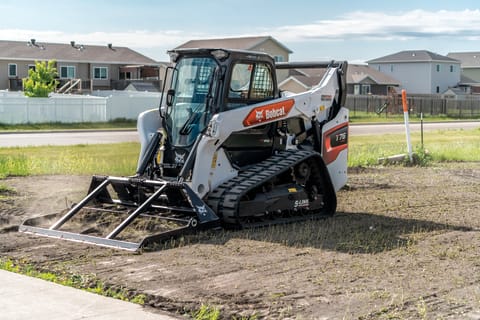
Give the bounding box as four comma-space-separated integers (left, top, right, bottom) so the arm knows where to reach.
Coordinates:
367, 50, 461, 94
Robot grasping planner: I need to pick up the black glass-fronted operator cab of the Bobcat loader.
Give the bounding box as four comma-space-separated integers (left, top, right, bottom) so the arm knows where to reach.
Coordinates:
162, 49, 280, 177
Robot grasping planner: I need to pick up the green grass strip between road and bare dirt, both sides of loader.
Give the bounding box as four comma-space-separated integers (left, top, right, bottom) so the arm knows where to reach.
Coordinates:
0, 129, 480, 178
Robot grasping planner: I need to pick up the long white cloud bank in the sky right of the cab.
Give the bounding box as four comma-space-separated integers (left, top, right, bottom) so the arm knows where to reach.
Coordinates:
270, 10, 480, 42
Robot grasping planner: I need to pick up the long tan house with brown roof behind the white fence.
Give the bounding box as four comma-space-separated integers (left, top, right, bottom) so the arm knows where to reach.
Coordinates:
0, 39, 166, 91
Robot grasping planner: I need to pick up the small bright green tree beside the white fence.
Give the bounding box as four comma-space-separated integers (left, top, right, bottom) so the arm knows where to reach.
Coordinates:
23, 60, 58, 97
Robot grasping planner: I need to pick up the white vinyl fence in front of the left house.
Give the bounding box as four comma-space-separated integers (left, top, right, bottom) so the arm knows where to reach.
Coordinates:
0, 91, 160, 124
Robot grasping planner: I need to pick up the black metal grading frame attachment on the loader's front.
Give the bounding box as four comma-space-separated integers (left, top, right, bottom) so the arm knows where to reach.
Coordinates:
19, 176, 219, 251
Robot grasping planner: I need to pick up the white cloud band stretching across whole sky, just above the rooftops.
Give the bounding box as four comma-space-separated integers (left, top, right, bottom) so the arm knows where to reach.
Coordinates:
0, 10, 480, 59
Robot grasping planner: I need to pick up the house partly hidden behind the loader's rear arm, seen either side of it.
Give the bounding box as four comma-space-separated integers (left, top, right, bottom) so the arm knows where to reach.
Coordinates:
279, 64, 400, 95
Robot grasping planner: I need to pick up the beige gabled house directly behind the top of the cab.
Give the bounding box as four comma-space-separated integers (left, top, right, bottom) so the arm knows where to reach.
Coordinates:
175, 36, 293, 81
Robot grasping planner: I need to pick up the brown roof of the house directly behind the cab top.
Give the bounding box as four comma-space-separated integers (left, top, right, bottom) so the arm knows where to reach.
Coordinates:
175, 36, 293, 53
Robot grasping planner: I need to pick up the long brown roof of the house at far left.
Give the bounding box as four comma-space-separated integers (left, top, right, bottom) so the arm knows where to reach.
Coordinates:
0, 40, 158, 65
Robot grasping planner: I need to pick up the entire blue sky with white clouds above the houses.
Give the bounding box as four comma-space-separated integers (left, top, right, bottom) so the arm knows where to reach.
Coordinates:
0, 0, 480, 63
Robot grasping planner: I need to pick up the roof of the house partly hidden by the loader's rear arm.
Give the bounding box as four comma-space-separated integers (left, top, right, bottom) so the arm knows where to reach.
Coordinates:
289, 64, 400, 87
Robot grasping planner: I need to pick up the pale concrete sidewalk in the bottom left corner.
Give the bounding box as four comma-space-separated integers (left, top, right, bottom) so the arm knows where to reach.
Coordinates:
0, 270, 179, 320
